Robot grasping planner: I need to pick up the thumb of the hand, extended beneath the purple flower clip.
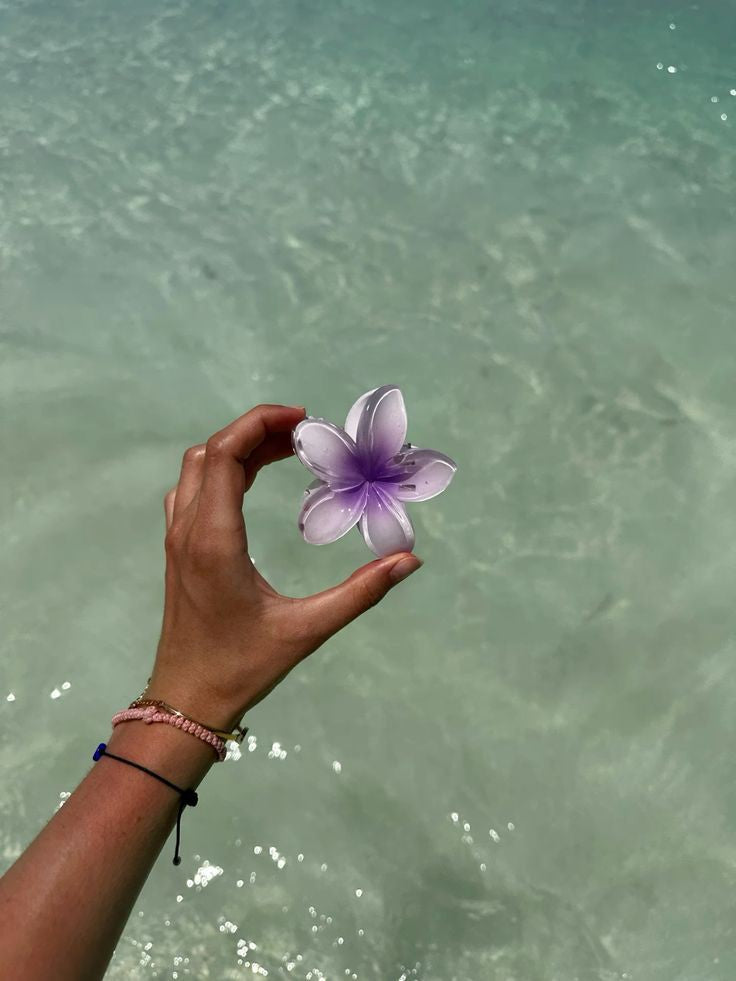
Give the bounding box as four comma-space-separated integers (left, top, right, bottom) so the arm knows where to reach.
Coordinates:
302, 552, 422, 643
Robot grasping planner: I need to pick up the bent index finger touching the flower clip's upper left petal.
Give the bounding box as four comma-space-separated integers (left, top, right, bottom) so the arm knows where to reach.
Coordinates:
197, 405, 305, 530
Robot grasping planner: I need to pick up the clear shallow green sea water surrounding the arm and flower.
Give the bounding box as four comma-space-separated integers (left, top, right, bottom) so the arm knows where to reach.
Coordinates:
0, 0, 736, 981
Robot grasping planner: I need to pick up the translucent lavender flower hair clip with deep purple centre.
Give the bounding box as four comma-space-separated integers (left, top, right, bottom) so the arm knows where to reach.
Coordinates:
292, 385, 457, 555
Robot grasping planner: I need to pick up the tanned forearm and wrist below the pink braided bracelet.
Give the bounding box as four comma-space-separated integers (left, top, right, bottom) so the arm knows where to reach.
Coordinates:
0, 722, 215, 981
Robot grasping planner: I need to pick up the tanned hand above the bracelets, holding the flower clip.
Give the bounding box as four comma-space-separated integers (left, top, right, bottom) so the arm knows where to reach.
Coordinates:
146, 405, 421, 728
